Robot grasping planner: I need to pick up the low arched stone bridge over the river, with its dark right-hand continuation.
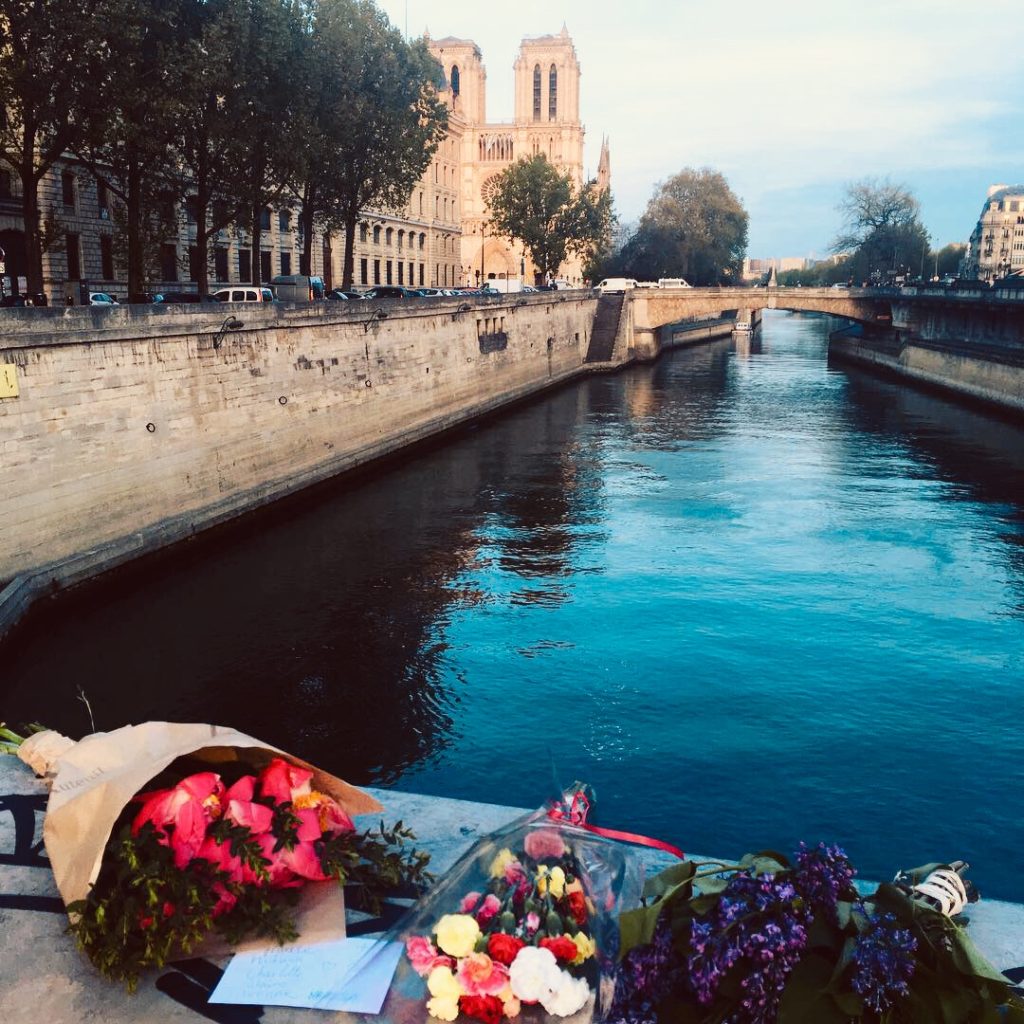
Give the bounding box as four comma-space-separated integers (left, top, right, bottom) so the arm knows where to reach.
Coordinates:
614, 288, 1024, 358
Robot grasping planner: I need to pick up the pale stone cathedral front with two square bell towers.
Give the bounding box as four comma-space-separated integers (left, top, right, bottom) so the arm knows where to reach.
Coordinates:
428, 27, 611, 286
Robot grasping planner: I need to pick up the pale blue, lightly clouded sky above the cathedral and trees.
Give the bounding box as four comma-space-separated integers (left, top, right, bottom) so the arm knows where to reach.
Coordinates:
378, 0, 1024, 258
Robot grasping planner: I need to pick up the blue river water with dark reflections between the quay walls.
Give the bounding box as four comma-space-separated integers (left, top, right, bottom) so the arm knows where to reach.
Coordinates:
0, 313, 1024, 900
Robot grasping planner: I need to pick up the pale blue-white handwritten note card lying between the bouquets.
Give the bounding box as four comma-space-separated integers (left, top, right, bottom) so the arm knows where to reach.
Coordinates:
210, 939, 402, 1014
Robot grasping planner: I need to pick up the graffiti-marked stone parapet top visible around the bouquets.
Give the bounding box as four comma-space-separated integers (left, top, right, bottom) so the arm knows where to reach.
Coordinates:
0, 756, 1024, 1024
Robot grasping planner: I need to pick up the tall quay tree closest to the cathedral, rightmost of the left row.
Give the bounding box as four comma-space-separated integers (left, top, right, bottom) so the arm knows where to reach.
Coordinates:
294, 0, 447, 289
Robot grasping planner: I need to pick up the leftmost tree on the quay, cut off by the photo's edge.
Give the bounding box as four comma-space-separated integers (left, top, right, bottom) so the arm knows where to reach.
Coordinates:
0, 0, 110, 293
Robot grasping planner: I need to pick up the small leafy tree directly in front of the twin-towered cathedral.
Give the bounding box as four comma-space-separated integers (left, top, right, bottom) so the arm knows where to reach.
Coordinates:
487, 154, 611, 278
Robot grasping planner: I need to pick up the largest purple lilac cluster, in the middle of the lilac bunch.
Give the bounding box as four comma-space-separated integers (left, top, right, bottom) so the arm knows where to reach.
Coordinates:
686, 874, 811, 1024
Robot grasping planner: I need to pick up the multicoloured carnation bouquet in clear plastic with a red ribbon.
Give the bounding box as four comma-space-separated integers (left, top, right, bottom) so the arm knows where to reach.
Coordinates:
339, 790, 642, 1024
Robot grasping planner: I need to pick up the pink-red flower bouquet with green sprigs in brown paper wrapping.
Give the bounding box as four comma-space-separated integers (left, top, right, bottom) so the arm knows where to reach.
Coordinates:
23, 722, 429, 988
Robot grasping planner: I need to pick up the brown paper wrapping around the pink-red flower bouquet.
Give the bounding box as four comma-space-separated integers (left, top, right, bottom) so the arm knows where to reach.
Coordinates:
43, 722, 382, 948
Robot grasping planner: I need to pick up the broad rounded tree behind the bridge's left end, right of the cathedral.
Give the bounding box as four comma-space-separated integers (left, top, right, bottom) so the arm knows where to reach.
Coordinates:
620, 167, 749, 285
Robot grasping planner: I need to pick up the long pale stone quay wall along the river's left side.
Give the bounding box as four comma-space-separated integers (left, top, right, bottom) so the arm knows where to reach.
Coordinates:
0, 293, 597, 618
